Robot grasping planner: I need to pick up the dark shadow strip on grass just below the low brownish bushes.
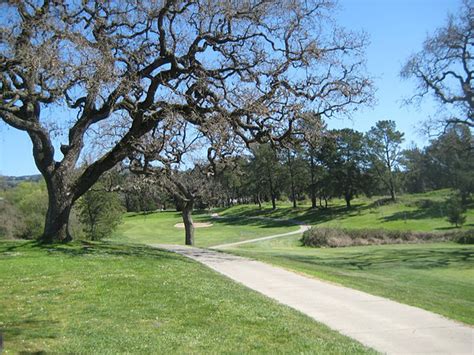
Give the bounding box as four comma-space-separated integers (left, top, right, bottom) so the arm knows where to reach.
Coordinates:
277, 247, 474, 270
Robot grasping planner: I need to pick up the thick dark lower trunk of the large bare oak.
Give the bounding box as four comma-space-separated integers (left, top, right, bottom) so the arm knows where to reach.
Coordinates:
40, 179, 73, 243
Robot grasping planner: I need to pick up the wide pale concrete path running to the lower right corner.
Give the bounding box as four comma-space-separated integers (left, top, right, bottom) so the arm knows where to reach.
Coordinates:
152, 244, 474, 354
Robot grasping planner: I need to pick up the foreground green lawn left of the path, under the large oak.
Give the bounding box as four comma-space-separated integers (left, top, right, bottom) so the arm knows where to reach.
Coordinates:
0, 242, 371, 354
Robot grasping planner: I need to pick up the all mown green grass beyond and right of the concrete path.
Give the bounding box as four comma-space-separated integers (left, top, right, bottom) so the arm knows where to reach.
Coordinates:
115, 190, 474, 324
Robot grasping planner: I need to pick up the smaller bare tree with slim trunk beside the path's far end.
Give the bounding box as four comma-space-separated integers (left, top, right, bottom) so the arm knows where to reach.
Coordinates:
128, 117, 221, 245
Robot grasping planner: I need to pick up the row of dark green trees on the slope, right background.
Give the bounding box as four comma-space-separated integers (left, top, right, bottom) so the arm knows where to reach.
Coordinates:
194, 121, 474, 208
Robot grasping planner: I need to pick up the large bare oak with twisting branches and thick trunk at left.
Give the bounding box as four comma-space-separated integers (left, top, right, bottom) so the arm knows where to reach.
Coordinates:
0, 0, 371, 242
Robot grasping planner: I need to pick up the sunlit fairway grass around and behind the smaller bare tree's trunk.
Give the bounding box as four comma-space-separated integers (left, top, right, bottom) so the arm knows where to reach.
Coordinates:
111, 211, 298, 247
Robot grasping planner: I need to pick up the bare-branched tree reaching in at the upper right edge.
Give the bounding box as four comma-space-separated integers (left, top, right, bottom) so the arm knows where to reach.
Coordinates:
401, 0, 474, 128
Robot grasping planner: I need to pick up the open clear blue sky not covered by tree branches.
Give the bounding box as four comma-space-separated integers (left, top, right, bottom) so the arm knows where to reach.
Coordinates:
0, 0, 461, 176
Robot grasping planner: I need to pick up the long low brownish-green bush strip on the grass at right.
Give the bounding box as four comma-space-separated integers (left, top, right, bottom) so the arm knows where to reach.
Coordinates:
300, 227, 474, 248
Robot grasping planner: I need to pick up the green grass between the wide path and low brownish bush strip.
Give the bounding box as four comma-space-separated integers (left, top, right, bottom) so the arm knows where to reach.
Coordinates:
227, 236, 474, 324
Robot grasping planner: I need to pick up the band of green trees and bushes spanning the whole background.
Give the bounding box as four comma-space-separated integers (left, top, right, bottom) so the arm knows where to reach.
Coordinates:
0, 121, 474, 244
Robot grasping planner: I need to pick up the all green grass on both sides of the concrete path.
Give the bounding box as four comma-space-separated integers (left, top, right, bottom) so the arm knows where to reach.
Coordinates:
0, 190, 474, 354
